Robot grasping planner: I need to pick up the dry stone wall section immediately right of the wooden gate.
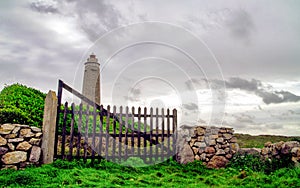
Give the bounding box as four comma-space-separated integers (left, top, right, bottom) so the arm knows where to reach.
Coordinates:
177, 126, 239, 168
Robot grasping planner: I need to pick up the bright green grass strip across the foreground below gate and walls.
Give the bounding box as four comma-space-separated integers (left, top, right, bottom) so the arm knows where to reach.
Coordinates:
0, 160, 300, 187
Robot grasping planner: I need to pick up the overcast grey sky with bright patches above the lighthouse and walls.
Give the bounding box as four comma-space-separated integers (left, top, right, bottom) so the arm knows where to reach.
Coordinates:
0, 0, 300, 136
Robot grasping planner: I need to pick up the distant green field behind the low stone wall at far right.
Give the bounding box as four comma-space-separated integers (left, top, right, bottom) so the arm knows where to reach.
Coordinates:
234, 134, 300, 148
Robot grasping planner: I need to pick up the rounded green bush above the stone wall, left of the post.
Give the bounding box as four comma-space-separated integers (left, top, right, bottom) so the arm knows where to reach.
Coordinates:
0, 84, 46, 127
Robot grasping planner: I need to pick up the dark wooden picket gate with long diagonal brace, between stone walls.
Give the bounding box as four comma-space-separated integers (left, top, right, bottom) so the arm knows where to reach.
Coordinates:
54, 80, 177, 164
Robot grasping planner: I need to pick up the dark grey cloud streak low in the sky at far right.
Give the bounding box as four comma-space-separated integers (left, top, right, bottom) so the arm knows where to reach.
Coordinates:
225, 77, 300, 104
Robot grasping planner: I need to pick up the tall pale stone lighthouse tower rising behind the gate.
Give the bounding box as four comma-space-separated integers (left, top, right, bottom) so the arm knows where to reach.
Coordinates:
82, 53, 101, 105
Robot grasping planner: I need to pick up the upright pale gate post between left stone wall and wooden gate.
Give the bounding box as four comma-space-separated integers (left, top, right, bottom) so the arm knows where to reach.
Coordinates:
42, 91, 57, 164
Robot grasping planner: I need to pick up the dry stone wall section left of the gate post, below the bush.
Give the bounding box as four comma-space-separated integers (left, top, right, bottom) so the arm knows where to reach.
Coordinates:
0, 124, 42, 169
